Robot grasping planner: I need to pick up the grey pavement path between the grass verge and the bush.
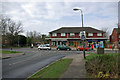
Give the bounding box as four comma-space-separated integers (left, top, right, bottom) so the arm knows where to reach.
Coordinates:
60, 54, 86, 80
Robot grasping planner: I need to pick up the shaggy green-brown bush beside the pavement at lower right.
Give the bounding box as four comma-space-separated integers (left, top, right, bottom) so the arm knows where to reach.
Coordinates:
85, 53, 118, 78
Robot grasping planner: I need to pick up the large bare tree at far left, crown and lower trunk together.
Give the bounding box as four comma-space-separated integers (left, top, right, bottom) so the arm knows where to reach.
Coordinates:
0, 15, 23, 46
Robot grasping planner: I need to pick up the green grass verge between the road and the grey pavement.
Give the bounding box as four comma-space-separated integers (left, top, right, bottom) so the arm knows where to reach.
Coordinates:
28, 59, 72, 80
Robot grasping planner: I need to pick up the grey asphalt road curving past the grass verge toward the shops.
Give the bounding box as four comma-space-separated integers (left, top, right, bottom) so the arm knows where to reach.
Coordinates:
2, 48, 82, 78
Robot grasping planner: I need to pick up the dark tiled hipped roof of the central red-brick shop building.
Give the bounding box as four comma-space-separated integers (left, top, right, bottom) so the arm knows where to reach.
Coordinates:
49, 27, 105, 33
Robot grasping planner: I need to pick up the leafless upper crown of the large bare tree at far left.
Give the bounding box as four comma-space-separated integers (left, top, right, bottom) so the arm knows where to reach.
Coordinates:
0, 15, 23, 35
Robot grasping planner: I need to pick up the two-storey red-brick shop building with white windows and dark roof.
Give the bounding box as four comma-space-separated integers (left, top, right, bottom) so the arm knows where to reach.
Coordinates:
46, 27, 107, 48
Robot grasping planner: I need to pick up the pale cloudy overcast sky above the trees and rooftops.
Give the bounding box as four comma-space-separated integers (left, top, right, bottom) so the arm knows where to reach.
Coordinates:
2, 2, 118, 34
